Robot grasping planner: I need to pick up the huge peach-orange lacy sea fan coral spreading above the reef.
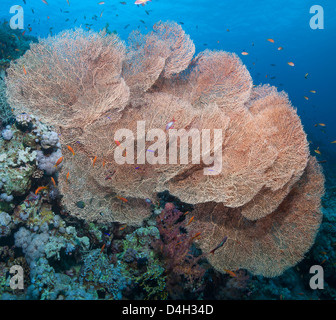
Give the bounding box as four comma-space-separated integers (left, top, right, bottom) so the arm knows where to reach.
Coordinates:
6, 22, 324, 277
